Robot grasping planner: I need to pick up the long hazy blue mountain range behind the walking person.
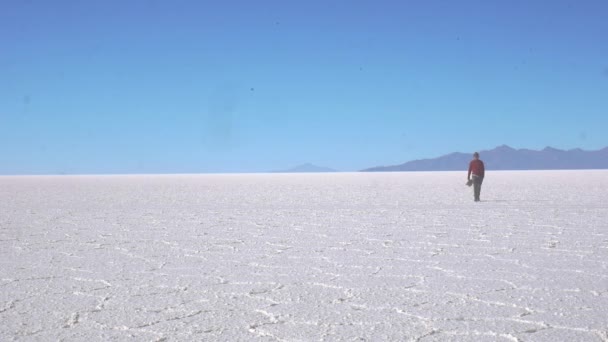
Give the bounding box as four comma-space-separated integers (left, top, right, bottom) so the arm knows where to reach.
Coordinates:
362, 145, 608, 172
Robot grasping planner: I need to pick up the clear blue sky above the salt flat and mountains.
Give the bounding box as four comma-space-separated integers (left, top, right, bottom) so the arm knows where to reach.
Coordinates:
0, 0, 608, 174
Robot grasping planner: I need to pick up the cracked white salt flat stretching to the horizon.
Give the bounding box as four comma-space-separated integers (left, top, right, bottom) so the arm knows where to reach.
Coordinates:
0, 171, 608, 341
